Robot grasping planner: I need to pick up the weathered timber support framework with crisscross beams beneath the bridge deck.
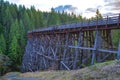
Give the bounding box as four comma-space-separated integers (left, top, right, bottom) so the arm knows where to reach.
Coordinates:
23, 30, 117, 71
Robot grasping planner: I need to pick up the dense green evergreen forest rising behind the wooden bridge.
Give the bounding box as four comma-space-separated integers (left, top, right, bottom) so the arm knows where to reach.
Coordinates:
0, 0, 120, 72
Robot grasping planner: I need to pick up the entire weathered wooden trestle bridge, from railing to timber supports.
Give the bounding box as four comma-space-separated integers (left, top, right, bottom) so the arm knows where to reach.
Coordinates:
22, 14, 120, 72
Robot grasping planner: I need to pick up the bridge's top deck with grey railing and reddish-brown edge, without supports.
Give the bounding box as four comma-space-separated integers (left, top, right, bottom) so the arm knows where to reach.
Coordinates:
28, 14, 120, 34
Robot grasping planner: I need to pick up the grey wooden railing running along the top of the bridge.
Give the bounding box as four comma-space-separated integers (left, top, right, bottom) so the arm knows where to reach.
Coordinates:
28, 14, 120, 33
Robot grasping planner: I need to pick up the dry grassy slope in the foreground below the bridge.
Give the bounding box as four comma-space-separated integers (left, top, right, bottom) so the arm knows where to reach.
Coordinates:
0, 60, 120, 80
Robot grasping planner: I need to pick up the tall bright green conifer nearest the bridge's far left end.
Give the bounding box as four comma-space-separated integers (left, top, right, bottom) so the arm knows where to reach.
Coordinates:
8, 19, 22, 65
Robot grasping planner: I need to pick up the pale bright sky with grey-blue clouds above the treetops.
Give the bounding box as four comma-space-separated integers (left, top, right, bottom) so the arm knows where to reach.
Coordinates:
5, 0, 120, 17
